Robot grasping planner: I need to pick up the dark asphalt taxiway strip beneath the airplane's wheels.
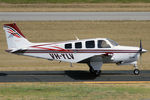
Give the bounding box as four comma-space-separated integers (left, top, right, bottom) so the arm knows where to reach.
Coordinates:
0, 70, 150, 82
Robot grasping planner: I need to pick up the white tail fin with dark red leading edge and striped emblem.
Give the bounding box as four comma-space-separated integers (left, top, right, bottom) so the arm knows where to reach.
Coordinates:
3, 23, 31, 49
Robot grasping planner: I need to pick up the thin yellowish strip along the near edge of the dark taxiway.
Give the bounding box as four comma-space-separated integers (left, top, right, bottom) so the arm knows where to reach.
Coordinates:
0, 81, 150, 84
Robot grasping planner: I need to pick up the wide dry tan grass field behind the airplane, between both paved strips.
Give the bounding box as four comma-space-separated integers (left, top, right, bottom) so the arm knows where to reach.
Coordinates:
0, 21, 150, 71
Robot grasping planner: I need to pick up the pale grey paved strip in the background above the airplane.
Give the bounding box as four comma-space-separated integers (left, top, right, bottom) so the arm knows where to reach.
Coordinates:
0, 12, 150, 21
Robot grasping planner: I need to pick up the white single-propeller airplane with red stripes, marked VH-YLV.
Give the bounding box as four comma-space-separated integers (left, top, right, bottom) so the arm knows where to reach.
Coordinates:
3, 23, 147, 76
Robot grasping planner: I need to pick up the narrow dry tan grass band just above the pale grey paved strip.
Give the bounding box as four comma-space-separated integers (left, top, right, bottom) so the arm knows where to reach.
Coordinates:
0, 3, 150, 12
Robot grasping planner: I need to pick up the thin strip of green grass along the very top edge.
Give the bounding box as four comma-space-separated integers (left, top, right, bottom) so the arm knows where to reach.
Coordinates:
0, 0, 150, 4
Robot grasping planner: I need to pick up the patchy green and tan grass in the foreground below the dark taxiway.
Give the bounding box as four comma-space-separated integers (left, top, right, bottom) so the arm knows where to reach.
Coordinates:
0, 83, 150, 100
